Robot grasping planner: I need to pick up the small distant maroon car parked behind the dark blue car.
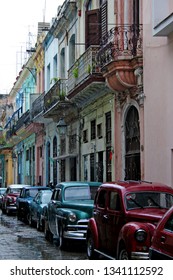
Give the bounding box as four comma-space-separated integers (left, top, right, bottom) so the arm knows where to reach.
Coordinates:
1, 184, 28, 214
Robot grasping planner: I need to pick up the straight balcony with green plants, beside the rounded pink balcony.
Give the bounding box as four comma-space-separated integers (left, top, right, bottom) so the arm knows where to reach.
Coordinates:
67, 46, 110, 107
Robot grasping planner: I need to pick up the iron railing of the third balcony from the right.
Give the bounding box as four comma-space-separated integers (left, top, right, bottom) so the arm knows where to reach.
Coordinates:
44, 79, 67, 112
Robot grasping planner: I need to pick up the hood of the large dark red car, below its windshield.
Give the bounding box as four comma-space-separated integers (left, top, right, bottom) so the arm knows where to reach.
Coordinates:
127, 208, 168, 222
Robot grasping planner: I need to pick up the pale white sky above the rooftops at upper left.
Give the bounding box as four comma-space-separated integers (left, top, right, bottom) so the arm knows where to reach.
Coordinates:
0, 0, 64, 94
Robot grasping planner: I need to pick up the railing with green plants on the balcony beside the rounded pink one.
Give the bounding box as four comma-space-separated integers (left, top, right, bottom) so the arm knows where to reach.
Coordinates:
68, 46, 101, 92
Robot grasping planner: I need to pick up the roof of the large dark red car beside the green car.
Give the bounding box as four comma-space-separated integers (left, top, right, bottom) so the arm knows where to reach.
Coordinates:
101, 180, 173, 193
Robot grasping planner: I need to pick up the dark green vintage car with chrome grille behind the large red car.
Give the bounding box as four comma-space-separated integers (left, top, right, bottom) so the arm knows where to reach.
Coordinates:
43, 182, 101, 249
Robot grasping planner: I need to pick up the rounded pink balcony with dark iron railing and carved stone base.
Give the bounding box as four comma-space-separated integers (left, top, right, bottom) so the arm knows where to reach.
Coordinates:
97, 25, 143, 91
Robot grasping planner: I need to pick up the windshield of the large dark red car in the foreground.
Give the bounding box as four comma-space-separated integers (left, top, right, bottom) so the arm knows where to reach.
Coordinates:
125, 191, 173, 210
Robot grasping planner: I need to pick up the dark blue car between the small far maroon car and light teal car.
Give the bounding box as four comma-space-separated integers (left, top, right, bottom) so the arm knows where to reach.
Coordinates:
16, 186, 49, 223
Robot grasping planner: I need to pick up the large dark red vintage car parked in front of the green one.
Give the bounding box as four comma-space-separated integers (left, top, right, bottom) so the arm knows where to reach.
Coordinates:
86, 181, 173, 260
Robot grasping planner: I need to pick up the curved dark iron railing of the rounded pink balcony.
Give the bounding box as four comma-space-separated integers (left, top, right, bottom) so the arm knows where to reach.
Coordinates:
97, 24, 143, 67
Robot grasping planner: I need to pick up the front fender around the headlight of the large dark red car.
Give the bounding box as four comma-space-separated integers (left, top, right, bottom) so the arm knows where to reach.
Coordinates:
117, 222, 155, 255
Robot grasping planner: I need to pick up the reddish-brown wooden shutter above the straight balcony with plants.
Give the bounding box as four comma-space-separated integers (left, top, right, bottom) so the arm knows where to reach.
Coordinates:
85, 9, 101, 48
